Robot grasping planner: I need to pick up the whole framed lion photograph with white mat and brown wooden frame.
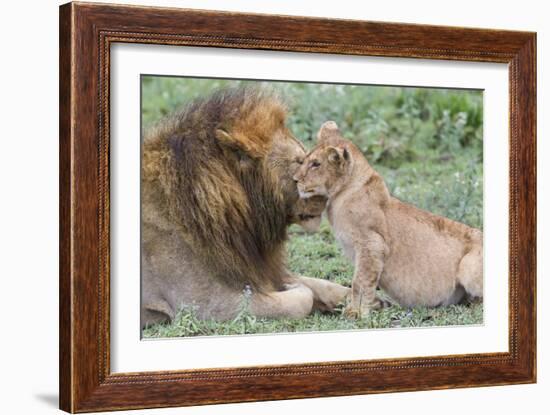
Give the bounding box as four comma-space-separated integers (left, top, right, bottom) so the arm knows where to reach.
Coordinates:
60, 3, 536, 412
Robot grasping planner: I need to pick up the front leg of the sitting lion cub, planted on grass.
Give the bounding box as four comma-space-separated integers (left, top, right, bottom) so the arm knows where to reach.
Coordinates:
344, 233, 387, 318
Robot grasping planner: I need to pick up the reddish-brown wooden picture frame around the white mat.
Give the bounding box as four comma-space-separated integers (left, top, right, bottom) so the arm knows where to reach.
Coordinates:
59, 3, 536, 412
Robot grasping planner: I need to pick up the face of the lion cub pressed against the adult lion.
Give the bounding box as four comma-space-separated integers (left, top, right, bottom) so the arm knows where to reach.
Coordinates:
294, 144, 350, 199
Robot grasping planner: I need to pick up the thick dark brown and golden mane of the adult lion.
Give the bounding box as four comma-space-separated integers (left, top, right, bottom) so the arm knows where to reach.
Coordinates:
142, 87, 296, 291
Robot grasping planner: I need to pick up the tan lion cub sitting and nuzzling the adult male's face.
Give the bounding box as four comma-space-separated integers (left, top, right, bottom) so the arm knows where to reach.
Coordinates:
294, 121, 483, 316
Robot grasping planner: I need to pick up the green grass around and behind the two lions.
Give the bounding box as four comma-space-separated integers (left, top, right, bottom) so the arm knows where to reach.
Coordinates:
142, 77, 483, 337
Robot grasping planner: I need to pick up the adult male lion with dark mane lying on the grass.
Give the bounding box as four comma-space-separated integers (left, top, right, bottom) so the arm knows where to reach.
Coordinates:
141, 88, 348, 326
